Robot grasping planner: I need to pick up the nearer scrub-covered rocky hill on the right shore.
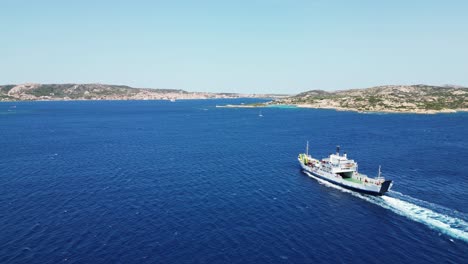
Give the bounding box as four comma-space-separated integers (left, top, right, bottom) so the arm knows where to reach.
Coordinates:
269, 85, 468, 113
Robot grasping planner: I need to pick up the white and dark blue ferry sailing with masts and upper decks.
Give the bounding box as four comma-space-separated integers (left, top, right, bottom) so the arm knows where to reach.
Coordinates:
298, 142, 393, 196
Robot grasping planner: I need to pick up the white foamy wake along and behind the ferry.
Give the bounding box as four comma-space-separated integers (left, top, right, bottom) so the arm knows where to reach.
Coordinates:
305, 172, 468, 243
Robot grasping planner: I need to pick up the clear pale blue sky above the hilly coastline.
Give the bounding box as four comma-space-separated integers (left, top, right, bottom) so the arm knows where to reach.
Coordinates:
0, 0, 468, 93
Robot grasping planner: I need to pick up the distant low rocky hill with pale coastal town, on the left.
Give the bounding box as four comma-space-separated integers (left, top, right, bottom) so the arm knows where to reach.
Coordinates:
0, 83, 269, 101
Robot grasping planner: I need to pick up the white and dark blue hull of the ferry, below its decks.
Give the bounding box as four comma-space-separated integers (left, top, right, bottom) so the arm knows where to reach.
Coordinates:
300, 162, 392, 196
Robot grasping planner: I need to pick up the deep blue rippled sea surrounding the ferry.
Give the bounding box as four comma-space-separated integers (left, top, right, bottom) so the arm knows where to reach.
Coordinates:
0, 99, 468, 264
